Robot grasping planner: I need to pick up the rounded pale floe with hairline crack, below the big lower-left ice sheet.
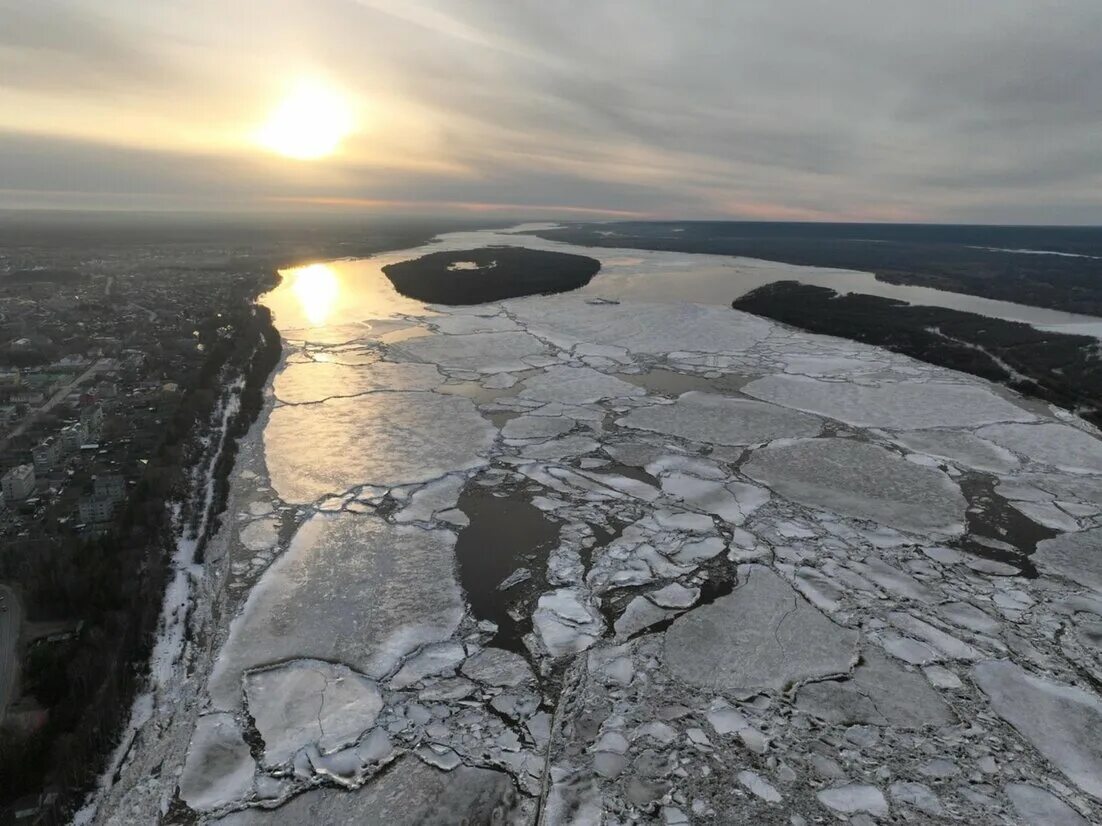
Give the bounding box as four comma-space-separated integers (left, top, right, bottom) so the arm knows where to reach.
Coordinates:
245, 660, 382, 765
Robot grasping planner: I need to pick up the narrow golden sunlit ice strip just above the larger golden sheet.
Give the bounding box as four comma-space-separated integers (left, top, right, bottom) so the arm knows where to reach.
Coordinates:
272, 361, 444, 404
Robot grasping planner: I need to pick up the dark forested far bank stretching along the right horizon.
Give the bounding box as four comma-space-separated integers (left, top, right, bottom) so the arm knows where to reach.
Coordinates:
536, 221, 1102, 316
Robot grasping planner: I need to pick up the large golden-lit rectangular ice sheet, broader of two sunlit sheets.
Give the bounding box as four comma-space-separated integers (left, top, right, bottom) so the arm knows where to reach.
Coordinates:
264, 391, 496, 504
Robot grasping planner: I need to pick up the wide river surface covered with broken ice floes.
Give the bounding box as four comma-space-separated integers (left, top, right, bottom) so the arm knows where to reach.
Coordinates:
92, 226, 1102, 826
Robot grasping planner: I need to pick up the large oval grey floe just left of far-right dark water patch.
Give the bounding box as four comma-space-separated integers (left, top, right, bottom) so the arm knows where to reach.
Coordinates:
742, 438, 966, 535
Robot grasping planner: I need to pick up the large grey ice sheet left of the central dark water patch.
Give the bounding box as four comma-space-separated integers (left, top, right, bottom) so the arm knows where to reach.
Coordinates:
208, 513, 463, 710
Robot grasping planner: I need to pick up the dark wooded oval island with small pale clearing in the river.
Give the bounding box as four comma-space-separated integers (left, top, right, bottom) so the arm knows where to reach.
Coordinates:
382, 247, 601, 305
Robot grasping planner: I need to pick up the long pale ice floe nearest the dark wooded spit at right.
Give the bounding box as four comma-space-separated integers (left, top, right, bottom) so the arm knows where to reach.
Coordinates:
743, 376, 1036, 435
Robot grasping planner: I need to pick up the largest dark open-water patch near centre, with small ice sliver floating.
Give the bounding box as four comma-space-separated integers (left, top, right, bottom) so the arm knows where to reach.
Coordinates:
455, 486, 559, 656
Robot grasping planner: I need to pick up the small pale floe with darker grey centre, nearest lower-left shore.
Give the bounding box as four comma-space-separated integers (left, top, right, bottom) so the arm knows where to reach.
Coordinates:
180, 714, 257, 812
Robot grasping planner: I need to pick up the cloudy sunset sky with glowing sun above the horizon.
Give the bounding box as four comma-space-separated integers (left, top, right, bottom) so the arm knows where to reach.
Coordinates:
0, 0, 1102, 224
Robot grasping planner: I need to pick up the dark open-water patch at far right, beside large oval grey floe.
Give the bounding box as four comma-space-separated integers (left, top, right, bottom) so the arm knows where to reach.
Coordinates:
954, 474, 1057, 578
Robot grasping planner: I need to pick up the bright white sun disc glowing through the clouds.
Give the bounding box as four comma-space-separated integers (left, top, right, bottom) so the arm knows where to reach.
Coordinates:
258, 80, 354, 161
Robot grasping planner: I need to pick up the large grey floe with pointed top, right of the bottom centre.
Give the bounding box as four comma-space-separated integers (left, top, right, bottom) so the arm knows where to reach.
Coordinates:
666, 565, 860, 697
